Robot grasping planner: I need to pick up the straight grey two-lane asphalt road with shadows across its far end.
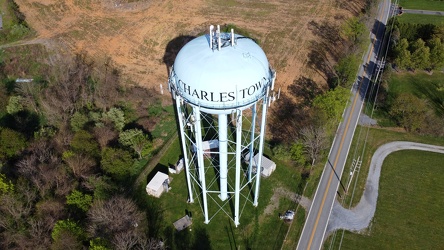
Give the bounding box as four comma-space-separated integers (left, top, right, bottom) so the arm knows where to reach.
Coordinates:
296, 0, 391, 250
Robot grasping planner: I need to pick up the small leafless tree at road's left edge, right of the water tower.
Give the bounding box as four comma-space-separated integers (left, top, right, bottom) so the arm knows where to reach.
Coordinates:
301, 125, 328, 166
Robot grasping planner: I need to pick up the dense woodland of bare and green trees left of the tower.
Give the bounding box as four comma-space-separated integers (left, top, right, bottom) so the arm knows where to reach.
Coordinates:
0, 53, 165, 249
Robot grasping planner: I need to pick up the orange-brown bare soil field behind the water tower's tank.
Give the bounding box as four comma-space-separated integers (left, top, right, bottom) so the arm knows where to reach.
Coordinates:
16, 0, 362, 91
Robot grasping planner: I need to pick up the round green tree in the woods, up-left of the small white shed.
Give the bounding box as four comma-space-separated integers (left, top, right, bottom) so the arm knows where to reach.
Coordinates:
100, 148, 133, 180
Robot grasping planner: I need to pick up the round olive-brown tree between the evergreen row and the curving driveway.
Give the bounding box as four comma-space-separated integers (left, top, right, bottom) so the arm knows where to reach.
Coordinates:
389, 93, 427, 131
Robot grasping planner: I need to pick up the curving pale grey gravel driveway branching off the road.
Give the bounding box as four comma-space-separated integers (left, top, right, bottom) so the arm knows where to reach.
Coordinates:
326, 141, 444, 235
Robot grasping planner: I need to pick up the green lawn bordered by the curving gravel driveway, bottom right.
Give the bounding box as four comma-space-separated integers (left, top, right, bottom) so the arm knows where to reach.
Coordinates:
327, 150, 444, 249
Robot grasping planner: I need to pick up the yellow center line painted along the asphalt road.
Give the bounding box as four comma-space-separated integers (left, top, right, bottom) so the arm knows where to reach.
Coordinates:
307, 2, 385, 249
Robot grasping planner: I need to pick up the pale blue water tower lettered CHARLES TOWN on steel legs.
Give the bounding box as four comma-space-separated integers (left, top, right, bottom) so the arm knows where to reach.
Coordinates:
169, 26, 276, 226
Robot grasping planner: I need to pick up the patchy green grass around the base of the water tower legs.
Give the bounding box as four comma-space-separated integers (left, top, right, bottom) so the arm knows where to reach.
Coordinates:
139, 137, 305, 249
